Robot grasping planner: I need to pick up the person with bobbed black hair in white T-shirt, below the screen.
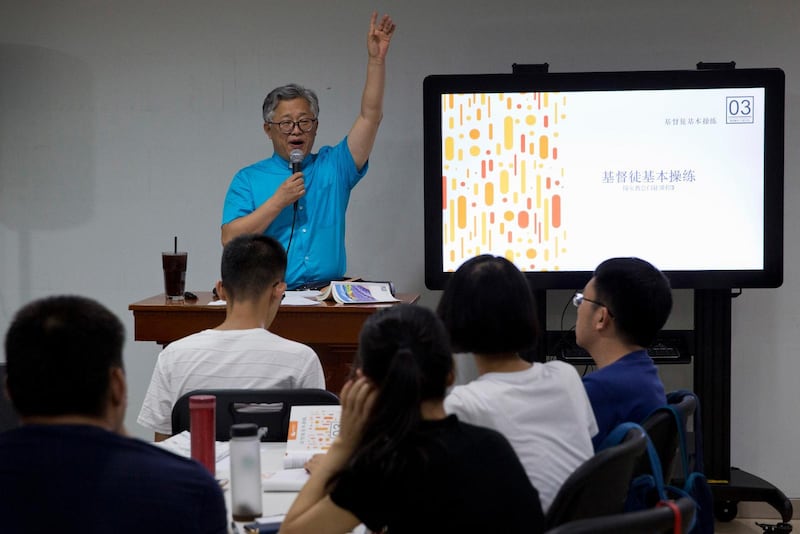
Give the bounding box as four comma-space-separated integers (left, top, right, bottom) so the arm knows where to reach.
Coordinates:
437, 254, 597, 513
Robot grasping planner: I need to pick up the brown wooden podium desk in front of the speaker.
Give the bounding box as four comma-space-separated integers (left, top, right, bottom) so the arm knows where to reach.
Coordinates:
128, 291, 419, 395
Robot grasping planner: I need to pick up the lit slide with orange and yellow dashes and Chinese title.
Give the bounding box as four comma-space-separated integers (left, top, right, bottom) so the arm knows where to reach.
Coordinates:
441, 88, 765, 271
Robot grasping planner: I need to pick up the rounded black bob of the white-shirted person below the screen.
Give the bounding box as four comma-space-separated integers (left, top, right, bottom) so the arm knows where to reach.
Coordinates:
437, 254, 539, 354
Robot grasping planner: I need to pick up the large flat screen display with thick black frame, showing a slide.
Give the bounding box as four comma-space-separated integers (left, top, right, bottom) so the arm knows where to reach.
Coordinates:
423, 69, 784, 289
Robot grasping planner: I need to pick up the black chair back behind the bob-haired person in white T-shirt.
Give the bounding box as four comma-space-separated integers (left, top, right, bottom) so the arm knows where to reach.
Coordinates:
545, 428, 647, 528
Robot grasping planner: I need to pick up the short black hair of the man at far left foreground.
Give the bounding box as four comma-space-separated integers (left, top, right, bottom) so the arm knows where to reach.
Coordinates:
5, 296, 125, 417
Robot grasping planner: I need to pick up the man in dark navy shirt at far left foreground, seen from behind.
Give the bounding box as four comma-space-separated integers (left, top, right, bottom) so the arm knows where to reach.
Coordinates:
0, 296, 227, 534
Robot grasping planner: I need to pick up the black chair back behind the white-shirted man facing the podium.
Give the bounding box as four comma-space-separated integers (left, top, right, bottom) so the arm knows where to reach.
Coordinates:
172, 388, 339, 441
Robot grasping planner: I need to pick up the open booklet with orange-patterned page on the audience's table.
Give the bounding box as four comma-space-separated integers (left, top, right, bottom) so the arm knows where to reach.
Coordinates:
262, 405, 342, 491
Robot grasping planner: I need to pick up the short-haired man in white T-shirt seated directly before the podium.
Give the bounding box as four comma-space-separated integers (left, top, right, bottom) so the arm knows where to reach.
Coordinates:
137, 234, 325, 441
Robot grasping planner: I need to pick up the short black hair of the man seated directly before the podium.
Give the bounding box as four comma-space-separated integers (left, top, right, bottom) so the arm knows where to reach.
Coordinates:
221, 234, 286, 301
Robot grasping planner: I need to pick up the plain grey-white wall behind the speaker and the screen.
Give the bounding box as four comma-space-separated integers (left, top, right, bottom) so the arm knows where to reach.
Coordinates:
0, 0, 800, 497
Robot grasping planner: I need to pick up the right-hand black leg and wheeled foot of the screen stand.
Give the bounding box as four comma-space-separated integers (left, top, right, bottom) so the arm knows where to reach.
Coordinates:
694, 289, 793, 532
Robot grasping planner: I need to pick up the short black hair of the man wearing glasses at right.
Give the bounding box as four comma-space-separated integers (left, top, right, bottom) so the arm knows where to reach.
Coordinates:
594, 258, 672, 347
